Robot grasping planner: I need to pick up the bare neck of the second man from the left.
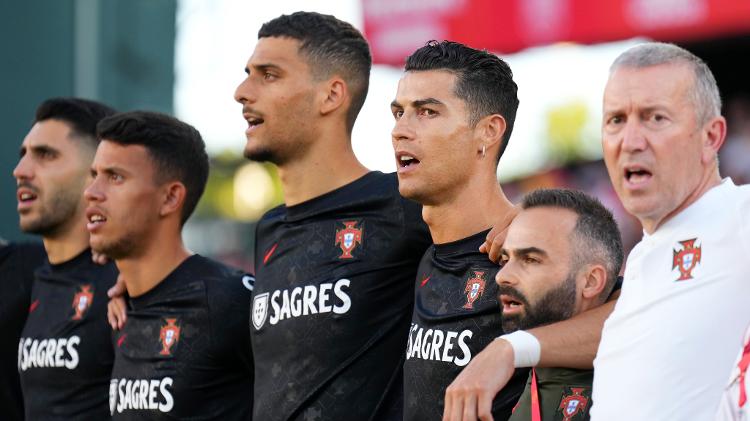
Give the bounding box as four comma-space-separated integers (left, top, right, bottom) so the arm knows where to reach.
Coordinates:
115, 232, 192, 297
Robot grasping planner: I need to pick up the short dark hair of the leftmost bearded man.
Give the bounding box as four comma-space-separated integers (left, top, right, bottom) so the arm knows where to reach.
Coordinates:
33, 97, 116, 148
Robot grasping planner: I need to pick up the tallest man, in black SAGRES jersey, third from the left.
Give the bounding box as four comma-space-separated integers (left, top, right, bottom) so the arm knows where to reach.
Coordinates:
235, 12, 429, 420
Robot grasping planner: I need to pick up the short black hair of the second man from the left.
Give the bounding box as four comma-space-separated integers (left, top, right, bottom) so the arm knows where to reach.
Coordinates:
97, 111, 208, 225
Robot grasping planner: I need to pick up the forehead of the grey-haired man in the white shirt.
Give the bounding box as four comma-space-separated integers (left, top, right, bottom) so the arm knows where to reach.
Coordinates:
604, 64, 694, 110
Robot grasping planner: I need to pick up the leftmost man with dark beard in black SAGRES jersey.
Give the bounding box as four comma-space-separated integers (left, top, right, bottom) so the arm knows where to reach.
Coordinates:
12, 98, 117, 419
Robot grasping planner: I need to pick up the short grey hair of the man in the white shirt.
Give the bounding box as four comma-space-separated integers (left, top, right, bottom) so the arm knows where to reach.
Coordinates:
609, 42, 721, 124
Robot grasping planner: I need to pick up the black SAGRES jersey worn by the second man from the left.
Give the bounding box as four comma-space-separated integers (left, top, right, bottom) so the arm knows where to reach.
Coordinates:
109, 255, 254, 420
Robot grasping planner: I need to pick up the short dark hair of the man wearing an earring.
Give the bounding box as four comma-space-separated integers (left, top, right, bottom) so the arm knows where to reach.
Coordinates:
404, 40, 518, 161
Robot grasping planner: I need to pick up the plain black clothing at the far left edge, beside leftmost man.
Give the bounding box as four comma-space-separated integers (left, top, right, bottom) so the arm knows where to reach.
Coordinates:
0, 243, 47, 421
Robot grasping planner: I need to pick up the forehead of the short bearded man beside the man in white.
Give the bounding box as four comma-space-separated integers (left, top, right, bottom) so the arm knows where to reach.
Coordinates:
503, 206, 578, 251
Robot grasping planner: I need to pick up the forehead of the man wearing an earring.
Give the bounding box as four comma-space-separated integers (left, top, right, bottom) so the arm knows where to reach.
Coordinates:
396, 70, 463, 105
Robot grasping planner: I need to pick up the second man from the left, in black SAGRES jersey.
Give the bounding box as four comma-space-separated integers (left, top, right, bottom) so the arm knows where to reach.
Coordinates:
84, 112, 253, 420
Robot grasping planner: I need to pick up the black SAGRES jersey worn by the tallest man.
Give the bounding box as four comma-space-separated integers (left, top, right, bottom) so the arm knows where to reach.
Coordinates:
250, 172, 430, 421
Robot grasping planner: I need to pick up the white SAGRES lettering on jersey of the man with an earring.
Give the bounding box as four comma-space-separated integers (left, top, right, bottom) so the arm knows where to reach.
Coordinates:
406, 323, 473, 367
